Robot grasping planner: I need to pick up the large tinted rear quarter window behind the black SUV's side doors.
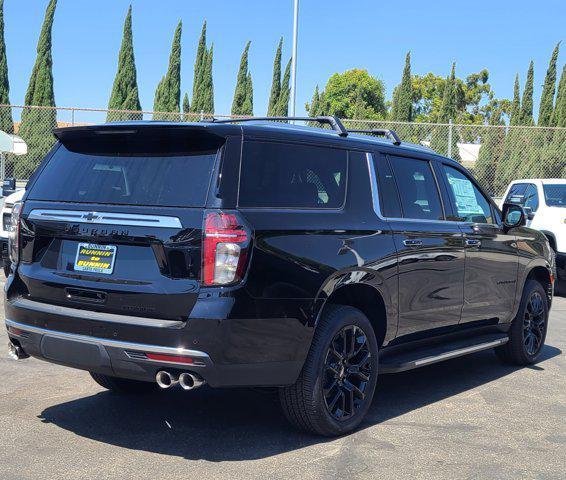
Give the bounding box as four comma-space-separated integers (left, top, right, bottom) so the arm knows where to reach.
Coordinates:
239, 142, 348, 208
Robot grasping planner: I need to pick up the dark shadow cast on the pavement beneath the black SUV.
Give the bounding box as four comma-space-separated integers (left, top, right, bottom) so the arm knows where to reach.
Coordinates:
40, 346, 561, 462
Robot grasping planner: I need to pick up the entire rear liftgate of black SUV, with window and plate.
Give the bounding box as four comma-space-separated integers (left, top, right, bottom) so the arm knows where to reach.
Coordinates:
11, 126, 225, 320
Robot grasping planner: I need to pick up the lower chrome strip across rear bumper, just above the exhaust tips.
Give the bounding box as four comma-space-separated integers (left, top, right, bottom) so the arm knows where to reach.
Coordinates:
5, 319, 210, 360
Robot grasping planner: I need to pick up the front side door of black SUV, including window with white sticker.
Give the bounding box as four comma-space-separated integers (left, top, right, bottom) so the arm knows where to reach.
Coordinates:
439, 164, 528, 323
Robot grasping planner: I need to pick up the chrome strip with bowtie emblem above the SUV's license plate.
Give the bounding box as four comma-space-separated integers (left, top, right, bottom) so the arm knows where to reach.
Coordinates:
28, 209, 183, 228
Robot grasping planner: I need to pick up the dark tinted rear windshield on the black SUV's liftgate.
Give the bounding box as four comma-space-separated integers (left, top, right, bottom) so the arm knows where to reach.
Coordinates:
28, 145, 217, 207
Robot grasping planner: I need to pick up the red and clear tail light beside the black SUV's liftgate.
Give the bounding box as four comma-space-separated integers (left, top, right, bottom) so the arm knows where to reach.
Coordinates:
202, 212, 249, 285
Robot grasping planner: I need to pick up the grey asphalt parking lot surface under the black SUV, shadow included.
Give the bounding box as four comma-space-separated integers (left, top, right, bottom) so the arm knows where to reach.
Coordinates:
0, 284, 566, 480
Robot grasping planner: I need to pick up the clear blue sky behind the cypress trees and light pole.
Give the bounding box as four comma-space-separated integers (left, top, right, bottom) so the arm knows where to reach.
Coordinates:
4, 0, 566, 120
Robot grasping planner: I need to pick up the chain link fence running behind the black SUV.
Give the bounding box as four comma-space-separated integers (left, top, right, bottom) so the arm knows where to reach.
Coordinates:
0, 105, 566, 197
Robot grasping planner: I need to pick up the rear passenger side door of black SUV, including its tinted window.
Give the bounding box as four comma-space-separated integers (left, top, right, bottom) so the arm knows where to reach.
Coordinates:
378, 155, 464, 336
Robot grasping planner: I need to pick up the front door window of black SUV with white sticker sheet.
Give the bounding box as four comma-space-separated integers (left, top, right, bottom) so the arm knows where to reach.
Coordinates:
443, 165, 493, 223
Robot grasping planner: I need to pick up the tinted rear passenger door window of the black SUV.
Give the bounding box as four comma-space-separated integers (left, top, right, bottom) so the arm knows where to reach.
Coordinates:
389, 156, 444, 220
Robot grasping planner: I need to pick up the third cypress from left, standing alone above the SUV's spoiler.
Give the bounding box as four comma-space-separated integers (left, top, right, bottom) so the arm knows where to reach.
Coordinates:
106, 5, 142, 122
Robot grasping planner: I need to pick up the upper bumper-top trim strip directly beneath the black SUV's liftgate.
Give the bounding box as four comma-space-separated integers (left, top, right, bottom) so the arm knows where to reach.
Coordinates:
12, 298, 185, 328
